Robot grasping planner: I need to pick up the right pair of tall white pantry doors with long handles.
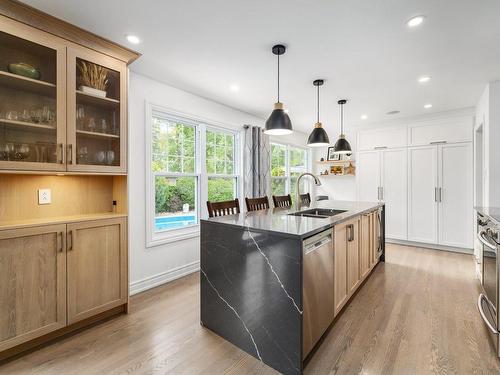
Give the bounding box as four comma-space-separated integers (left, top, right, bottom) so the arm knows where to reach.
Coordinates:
408, 142, 473, 249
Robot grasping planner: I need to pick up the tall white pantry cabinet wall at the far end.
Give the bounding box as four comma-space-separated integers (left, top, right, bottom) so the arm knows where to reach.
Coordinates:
356, 116, 473, 249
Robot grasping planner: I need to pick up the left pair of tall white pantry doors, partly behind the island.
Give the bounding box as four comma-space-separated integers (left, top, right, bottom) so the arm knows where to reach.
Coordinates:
357, 148, 407, 240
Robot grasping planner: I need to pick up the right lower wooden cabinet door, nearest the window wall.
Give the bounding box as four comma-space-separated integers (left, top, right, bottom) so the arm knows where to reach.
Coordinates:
68, 218, 128, 324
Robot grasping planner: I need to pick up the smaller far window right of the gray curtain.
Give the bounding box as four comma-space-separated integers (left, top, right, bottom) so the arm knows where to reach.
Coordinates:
271, 143, 309, 200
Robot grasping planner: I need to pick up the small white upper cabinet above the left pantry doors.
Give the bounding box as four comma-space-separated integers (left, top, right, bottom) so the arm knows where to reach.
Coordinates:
358, 127, 407, 151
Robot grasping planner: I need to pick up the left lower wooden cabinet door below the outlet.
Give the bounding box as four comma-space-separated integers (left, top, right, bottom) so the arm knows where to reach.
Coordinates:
0, 224, 66, 351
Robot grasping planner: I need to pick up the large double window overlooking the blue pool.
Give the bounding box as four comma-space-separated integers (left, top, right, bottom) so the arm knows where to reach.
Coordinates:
146, 106, 239, 246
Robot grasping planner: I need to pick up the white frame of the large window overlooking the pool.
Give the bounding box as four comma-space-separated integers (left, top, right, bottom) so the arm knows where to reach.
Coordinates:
145, 102, 242, 248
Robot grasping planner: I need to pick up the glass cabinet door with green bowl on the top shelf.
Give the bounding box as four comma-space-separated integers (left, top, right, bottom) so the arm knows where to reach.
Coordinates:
0, 21, 66, 171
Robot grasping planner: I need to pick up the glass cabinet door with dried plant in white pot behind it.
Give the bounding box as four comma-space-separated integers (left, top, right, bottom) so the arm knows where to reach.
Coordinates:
67, 48, 127, 173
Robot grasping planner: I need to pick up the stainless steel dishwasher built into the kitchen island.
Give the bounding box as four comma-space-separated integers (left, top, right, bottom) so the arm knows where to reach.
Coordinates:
302, 228, 334, 357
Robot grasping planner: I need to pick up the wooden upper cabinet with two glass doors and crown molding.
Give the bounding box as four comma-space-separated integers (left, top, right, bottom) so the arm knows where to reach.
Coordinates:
0, 13, 137, 174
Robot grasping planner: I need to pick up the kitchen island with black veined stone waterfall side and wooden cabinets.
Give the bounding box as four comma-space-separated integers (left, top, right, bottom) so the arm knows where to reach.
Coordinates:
200, 201, 385, 374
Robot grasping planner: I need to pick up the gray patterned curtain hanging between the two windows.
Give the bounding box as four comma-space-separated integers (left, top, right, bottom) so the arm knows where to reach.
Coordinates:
243, 125, 271, 198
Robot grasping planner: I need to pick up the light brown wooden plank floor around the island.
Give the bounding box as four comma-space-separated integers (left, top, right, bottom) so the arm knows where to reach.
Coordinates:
0, 245, 500, 375
